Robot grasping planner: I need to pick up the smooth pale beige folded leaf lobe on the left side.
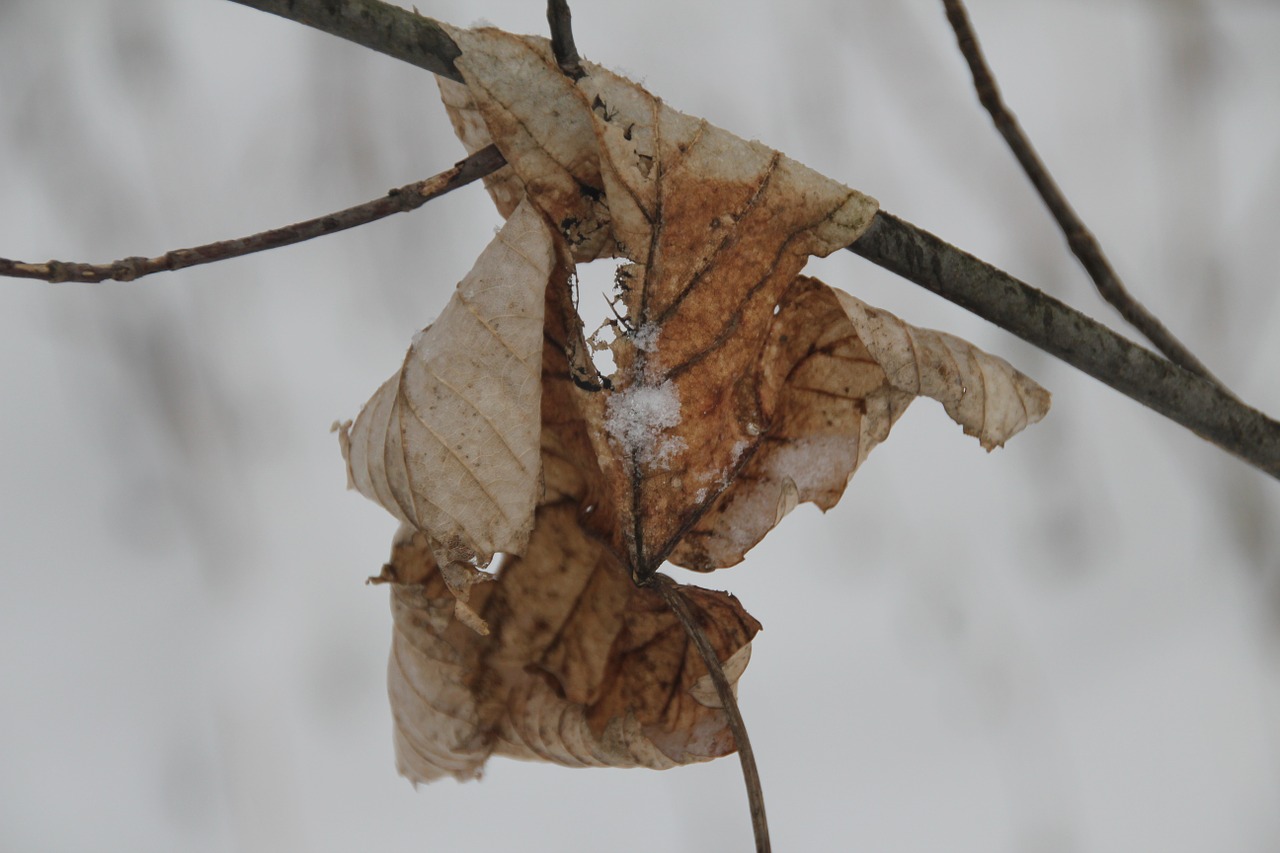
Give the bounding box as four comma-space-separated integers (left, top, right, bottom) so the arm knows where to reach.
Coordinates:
343, 204, 567, 571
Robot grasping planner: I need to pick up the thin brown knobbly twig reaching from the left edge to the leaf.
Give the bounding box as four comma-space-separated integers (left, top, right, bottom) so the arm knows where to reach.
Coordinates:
0, 145, 507, 282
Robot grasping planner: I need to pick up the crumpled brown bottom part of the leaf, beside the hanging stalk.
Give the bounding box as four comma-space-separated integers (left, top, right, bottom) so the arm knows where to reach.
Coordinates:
381, 502, 759, 783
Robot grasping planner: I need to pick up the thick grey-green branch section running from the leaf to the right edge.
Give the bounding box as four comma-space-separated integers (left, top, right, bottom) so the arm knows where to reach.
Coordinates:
849, 210, 1280, 478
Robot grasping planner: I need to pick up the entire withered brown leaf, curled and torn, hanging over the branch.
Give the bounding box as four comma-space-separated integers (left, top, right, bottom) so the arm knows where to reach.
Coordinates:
340, 28, 1048, 781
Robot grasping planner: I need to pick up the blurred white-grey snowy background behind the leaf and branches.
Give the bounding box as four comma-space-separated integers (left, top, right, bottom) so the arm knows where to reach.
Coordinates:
0, 0, 1280, 853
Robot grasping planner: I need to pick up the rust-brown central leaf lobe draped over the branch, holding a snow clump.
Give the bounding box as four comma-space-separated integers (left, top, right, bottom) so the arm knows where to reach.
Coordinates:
442, 23, 876, 576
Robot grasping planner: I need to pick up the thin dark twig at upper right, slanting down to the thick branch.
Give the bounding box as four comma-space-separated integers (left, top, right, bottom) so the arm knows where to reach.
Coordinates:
942, 0, 1230, 393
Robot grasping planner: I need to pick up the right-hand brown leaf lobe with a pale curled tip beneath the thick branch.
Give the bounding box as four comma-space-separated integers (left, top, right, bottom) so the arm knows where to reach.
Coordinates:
671, 277, 1050, 571
